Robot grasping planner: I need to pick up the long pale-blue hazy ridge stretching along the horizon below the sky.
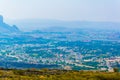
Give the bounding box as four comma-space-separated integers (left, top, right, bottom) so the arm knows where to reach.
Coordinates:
8, 19, 120, 31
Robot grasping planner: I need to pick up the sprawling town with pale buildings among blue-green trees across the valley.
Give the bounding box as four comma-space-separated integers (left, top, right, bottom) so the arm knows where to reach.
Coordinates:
0, 29, 120, 71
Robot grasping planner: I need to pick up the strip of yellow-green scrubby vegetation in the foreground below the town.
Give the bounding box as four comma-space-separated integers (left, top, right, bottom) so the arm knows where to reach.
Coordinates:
0, 69, 120, 80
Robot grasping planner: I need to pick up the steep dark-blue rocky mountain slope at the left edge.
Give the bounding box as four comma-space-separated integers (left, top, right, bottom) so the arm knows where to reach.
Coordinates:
0, 15, 20, 34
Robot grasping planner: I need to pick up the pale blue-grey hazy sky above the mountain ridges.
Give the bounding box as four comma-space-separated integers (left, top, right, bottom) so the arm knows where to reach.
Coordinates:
0, 0, 120, 22
